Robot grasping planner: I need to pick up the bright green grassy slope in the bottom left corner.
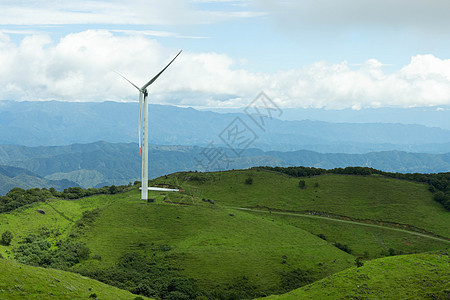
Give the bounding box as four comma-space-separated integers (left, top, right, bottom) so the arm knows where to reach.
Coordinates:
0, 259, 148, 300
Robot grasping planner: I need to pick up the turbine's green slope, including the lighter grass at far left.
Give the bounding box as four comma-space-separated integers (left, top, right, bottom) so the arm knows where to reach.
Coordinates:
0, 192, 354, 293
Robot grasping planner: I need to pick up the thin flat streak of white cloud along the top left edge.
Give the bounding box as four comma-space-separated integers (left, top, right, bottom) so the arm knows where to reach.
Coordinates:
0, 0, 263, 25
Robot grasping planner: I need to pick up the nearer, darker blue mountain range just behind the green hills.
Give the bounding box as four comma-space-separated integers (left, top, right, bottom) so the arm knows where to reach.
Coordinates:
0, 142, 450, 194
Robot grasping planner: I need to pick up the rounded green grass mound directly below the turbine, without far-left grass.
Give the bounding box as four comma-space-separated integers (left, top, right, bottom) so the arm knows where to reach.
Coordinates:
74, 194, 354, 291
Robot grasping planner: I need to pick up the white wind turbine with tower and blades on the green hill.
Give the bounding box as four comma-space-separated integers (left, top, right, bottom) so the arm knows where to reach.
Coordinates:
117, 51, 181, 200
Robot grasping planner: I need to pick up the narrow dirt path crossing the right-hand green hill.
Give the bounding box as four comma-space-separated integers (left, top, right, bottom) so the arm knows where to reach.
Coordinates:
231, 207, 450, 244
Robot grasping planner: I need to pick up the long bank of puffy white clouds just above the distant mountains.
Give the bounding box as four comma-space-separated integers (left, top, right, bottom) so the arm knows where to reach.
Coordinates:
0, 30, 450, 109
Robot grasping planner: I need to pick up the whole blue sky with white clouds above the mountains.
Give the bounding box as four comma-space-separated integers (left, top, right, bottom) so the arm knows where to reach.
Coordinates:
0, 0, 450, 110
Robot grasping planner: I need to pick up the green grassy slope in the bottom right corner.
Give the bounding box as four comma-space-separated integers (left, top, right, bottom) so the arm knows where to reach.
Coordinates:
265, 252, 450, 300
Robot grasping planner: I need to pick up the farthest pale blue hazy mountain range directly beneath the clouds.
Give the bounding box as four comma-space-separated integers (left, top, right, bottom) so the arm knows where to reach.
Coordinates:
0, 101, 450, 153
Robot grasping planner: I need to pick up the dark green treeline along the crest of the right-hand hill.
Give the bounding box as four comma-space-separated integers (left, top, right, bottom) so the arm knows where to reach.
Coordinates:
252, 166, 450, 211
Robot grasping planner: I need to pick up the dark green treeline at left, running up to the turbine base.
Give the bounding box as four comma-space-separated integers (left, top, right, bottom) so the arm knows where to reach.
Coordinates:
0, 182, 135, 213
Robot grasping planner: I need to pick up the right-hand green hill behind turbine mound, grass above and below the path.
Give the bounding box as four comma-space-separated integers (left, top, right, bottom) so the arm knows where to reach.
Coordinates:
156, 170, 450, 258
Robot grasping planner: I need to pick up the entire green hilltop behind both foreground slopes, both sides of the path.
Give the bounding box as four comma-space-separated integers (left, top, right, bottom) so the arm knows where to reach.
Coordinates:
0, 170, 450, 298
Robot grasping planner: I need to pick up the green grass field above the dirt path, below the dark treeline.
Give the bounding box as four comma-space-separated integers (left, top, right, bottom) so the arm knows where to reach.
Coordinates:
155, 170, 450, 238
